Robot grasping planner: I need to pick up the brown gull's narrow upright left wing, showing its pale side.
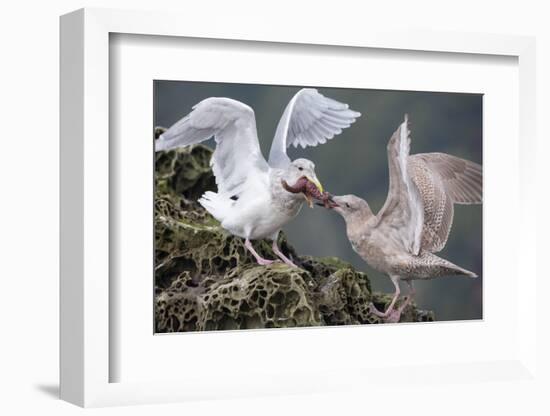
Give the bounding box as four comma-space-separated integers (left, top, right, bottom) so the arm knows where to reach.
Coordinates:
378, 115, 424, 255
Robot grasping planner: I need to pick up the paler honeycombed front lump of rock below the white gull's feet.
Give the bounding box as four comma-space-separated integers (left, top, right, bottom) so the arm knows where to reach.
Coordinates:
157, 264, 322, 331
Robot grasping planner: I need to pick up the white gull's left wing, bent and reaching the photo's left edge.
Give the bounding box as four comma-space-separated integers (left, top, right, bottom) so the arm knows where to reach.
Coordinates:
155, 97, 269, 193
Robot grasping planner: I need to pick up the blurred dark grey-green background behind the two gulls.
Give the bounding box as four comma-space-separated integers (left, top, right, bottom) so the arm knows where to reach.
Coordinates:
154, 81, 483, 320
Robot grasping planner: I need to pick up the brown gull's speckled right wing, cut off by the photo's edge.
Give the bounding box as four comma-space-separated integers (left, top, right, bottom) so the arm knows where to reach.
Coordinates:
407, 153, 483, 253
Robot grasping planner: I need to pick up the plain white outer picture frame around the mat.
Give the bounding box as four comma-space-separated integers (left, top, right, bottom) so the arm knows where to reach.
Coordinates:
60, 9, 537, 406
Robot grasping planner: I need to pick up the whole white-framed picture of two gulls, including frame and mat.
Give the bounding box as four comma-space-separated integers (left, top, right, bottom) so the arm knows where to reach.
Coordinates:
61, 9, 537, 406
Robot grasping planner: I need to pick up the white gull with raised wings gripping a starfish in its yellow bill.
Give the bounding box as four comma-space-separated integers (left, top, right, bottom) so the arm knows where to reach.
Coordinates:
155, 88, 360, 266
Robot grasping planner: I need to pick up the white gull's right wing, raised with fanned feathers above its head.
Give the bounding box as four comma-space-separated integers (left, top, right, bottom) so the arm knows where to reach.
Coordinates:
269, 88, 361, 168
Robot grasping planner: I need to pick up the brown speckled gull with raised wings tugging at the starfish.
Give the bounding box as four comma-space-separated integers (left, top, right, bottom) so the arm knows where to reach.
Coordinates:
333, 116, 482, 322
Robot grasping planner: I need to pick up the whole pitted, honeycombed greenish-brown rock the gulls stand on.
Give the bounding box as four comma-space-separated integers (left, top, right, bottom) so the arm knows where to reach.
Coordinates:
155, 141, 433, 332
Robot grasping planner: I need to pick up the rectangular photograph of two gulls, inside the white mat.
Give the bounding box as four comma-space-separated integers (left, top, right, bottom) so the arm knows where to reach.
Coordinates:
153, 80, 482, 333
